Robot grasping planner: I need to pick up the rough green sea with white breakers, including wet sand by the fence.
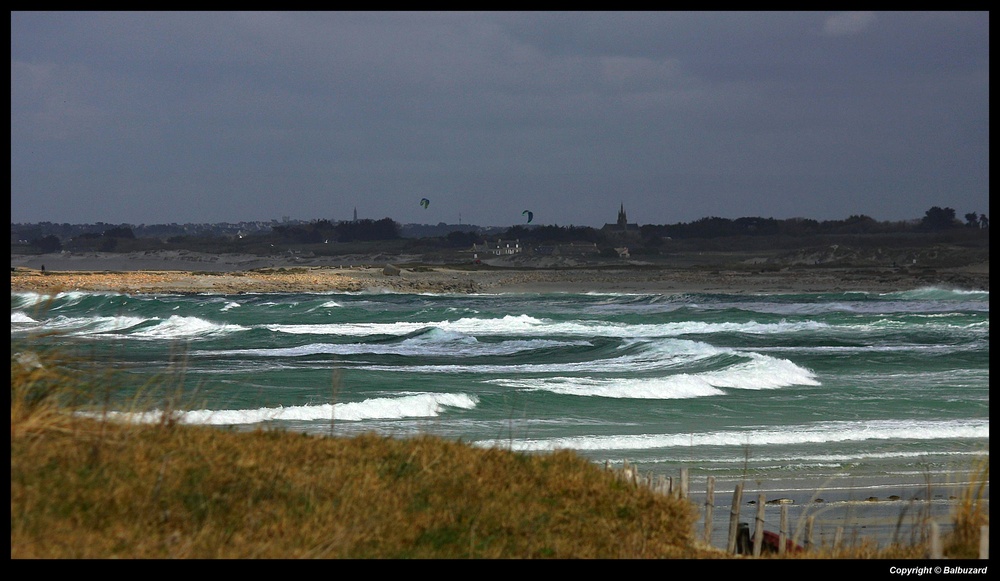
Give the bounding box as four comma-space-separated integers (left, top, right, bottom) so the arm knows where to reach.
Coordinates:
11, 287, 990, 547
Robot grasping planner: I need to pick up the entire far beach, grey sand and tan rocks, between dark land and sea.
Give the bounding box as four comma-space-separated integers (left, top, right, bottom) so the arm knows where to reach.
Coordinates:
11, 251, 989, 294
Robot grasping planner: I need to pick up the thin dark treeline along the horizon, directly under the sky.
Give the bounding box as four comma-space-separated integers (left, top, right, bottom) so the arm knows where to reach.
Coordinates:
11, 206, 989, 252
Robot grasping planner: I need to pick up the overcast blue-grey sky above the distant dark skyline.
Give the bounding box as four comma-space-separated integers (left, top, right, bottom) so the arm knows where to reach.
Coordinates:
10, 11, 990, 227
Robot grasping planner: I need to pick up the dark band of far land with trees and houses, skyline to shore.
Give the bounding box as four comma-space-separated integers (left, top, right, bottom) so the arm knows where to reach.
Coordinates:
11, 206, 989, 266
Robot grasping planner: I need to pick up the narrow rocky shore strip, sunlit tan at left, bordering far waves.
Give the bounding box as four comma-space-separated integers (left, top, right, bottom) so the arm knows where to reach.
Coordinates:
10, 267, 989, 294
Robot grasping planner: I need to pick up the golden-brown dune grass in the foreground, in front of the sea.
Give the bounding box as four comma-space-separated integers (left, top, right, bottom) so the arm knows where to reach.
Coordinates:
10, 348, 988, 559
